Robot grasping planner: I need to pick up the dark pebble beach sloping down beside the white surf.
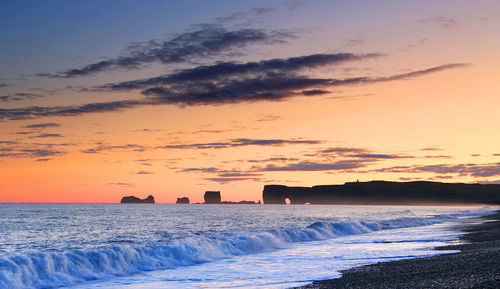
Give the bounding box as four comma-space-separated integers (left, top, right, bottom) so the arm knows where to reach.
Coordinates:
295, 210, 500, 289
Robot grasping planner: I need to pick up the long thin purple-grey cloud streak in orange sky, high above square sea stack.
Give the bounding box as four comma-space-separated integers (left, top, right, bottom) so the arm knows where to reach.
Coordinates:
159, 138, 323, 149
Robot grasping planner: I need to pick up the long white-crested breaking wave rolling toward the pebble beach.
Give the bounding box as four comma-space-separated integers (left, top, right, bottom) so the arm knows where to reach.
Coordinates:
0, 206, 492, 288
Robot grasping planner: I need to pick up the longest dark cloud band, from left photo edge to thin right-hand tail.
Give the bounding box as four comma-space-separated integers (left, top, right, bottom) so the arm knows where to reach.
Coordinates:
0, 63, 467, 120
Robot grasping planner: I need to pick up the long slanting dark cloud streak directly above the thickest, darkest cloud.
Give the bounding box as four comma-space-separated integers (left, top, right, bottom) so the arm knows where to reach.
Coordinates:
98, 53, 381, 92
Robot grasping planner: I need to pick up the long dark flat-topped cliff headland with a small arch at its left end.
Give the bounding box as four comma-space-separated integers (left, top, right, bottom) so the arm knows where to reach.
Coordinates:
263, 181, 500, 205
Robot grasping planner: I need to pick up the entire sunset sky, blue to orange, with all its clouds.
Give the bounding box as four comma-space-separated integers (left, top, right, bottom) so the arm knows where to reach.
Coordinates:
0, 0, 500, 203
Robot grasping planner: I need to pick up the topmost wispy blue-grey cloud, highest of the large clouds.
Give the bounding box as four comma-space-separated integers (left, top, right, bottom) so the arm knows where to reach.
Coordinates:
38, 24, 294, 78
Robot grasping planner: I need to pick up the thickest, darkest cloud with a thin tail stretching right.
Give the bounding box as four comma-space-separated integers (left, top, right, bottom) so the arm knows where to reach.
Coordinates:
142, 64, 466, 105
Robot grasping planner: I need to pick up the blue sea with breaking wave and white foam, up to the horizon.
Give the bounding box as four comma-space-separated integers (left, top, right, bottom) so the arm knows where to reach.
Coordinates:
0, 204, 494, 288
